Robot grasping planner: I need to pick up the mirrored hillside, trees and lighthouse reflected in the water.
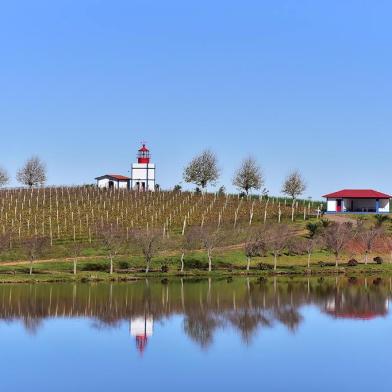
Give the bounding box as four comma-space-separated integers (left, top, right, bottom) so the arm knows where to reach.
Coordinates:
0, 278, 392, 353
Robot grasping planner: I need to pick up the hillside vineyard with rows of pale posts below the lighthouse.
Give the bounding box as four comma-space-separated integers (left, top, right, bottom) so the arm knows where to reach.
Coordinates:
0, 187, 320, 246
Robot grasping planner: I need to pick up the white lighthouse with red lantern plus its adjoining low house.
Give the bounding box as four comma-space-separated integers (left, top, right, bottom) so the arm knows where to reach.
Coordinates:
95, 144, 155, 191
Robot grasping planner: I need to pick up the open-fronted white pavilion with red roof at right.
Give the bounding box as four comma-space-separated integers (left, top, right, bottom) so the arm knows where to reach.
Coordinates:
323, 189, 392, 214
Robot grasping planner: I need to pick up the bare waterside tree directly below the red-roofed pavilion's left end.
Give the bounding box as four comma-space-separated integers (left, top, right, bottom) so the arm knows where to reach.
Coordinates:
322, 222, 353, 267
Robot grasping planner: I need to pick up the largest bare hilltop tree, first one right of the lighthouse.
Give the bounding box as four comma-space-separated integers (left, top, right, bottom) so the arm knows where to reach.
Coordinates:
183, 150, 219, 189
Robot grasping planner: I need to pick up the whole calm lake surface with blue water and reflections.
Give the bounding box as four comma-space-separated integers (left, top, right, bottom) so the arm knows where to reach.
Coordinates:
0, 277, 392, 391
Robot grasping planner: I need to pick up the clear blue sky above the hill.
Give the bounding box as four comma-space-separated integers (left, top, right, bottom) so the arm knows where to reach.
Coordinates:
0, 0, 392, 198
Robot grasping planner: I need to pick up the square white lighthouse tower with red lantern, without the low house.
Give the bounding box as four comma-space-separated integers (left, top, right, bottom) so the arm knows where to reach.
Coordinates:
131, 144, 155, 191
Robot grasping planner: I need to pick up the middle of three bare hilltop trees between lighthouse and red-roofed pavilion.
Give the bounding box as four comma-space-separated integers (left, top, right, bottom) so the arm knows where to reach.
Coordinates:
233, 157, 264, 195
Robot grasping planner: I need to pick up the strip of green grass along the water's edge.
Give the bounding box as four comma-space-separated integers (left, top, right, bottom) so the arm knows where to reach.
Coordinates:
0, 250, 392, 283
